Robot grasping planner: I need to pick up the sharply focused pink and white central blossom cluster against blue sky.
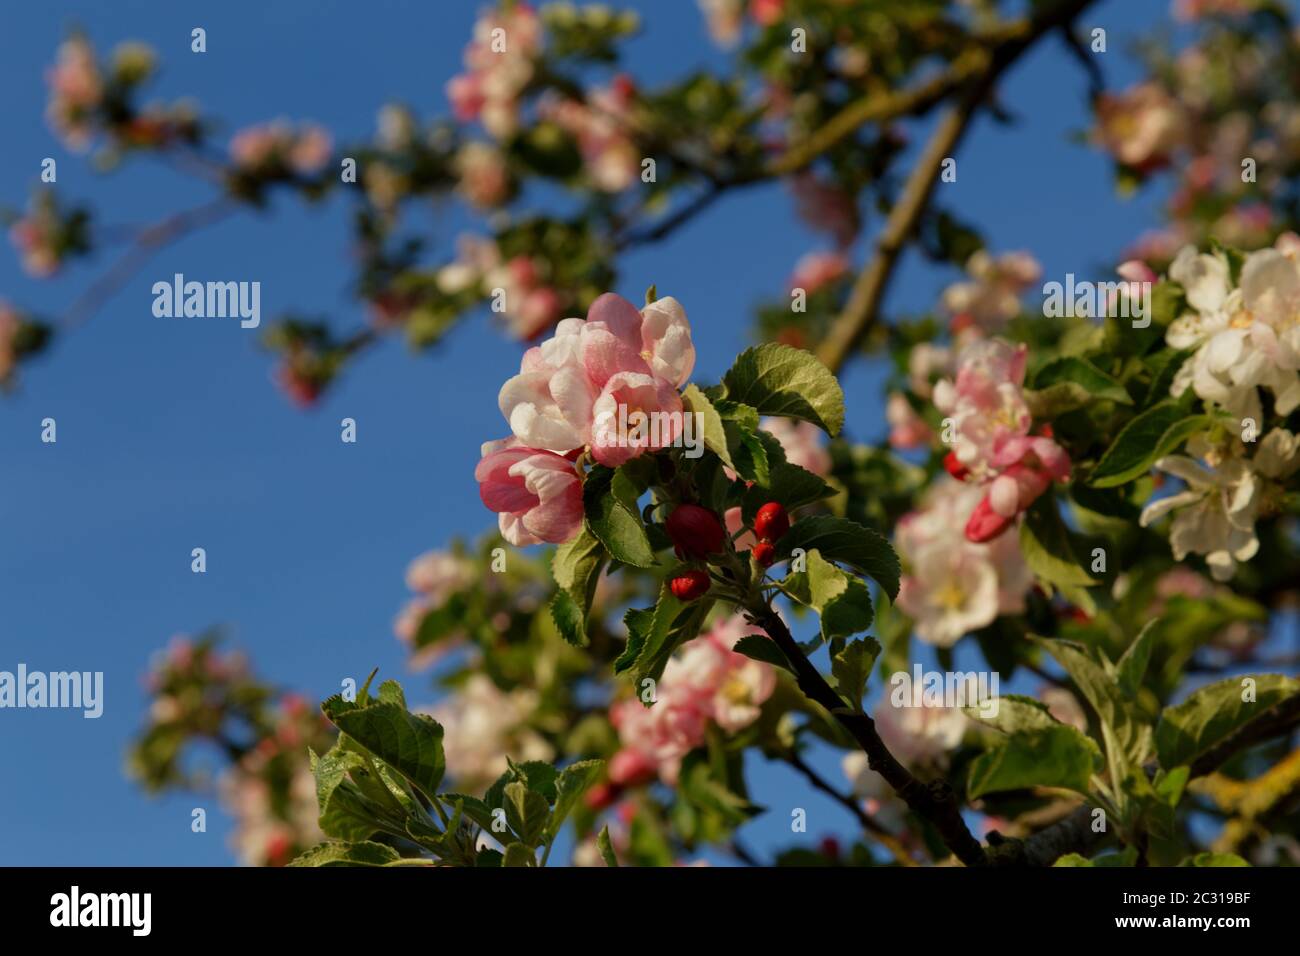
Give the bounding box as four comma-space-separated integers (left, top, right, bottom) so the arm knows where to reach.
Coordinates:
475, 293, 696, 545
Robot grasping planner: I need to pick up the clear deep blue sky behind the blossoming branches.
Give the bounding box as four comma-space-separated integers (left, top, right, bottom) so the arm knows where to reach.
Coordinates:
0, 0, 1166, 865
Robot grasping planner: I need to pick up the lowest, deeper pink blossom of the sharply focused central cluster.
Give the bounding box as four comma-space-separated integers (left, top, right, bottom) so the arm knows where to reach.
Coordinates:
475, 438, 582, 546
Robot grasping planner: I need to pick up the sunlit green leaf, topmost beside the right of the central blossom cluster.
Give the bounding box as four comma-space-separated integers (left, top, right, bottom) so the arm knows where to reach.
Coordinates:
723, 342, 844, 436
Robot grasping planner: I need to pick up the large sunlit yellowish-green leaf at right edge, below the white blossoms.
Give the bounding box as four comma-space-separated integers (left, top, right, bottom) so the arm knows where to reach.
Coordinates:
1156, 674, 1300, 767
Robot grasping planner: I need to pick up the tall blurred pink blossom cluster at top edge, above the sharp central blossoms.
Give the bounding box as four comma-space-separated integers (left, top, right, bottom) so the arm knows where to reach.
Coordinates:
447, 3, 542, 139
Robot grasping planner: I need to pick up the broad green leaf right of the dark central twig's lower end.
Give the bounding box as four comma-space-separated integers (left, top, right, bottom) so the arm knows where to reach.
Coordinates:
966, 723, 1101, 799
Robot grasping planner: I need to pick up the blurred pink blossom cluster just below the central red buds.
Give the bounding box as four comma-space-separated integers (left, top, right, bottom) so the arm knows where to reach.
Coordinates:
590, 614, 776, 790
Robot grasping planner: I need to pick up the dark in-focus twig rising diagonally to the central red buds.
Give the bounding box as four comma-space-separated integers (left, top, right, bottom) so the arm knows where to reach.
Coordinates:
745, 604, 987, 866
